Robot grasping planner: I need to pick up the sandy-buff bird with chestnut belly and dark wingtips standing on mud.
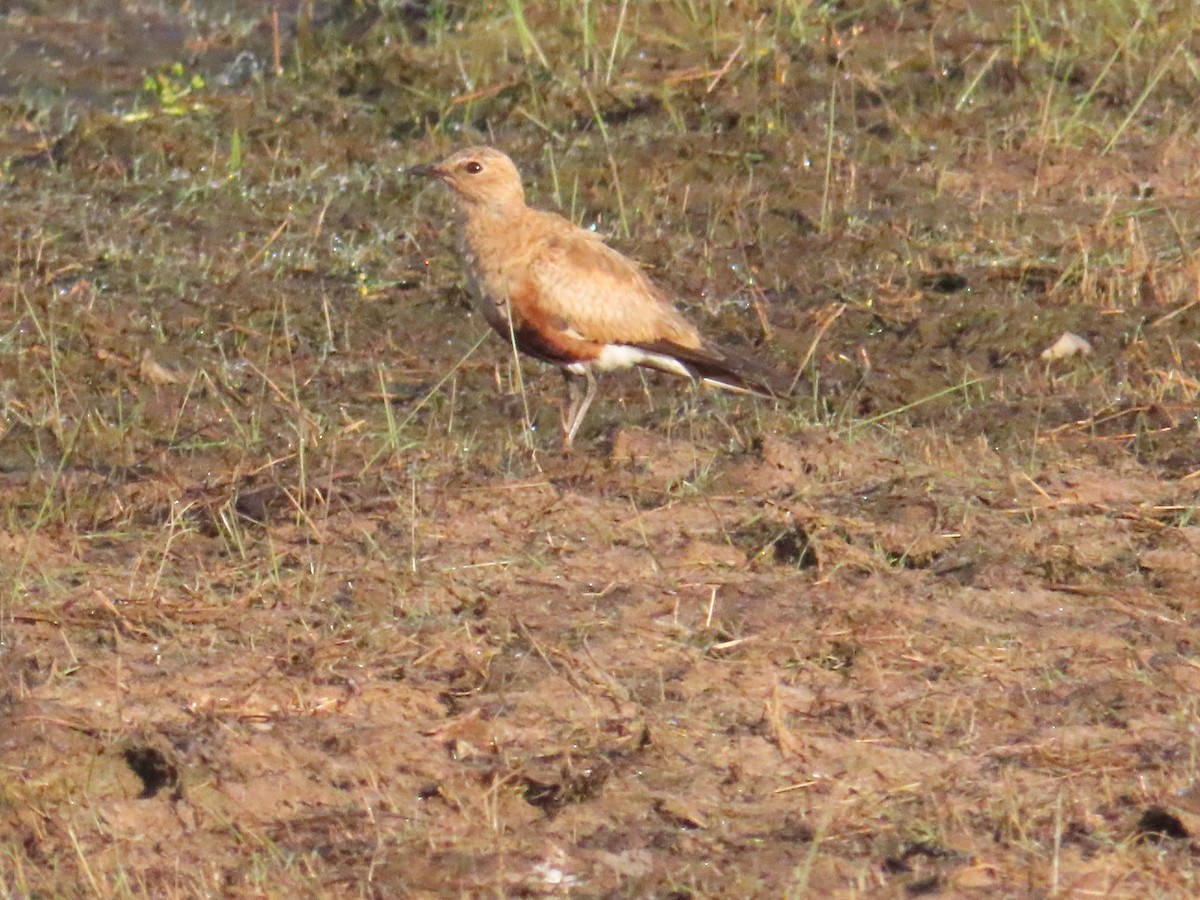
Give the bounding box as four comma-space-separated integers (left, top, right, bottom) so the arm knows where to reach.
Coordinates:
407, 146, 782, 452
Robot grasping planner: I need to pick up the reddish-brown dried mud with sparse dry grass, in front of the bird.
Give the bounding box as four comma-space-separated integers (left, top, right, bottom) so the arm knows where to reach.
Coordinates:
0, 431, 1198, 894
